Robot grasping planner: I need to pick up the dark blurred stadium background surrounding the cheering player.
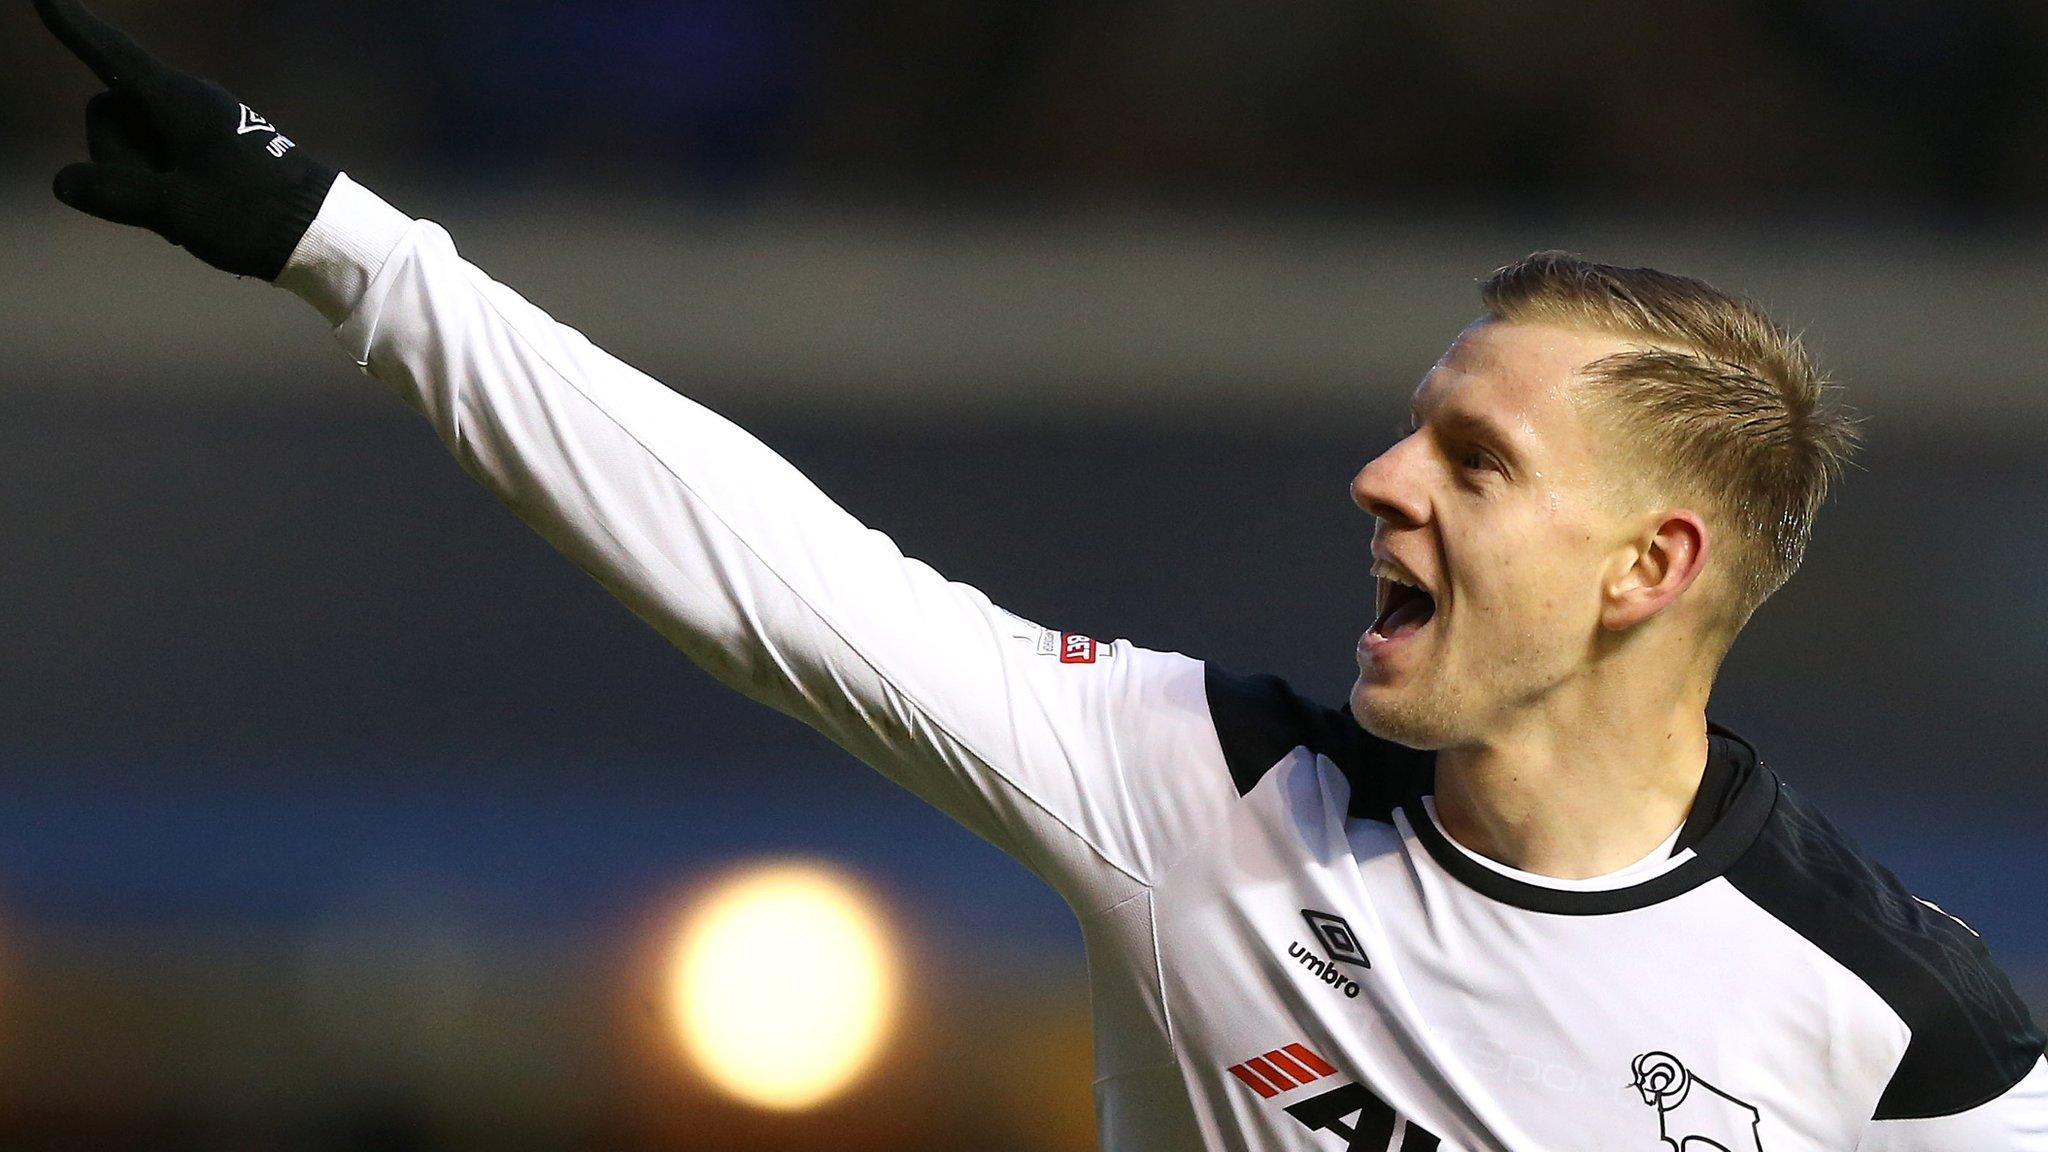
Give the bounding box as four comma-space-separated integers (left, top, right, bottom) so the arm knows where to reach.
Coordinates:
0, 0, 2048, 1152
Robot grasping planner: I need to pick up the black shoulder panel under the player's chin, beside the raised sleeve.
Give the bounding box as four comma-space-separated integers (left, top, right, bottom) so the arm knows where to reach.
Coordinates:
1206, 666, 1434, 820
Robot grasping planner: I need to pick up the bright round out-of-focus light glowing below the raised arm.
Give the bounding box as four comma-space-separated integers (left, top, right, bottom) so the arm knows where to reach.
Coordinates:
670, 863, 897, 1111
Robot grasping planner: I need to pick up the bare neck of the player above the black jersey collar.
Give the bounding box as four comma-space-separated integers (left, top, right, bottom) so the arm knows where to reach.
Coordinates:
1436, 699, 1708, 879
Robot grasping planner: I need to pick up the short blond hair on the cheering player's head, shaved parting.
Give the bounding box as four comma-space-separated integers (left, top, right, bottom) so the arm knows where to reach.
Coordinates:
1481, 252, 1860, 642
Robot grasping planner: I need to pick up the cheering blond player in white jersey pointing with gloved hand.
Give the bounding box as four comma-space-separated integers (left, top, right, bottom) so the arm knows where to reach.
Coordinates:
37, 0, 2048, 1152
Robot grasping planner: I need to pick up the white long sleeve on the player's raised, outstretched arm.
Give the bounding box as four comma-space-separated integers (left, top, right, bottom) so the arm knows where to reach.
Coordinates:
279, 176, 1235, 916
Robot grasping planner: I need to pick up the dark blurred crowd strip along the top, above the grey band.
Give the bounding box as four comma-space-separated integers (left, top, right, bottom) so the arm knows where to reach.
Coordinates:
12, 0, 2048, 221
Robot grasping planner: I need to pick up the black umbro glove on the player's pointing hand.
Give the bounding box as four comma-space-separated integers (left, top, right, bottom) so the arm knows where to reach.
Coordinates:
35, 0, 338, 281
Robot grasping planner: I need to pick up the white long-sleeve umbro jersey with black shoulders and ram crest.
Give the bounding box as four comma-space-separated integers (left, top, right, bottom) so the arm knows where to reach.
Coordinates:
281, 176, 2048, 1152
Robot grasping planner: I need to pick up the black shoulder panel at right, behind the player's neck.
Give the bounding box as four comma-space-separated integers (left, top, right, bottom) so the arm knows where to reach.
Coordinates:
1726, 789, 2042, 1119
